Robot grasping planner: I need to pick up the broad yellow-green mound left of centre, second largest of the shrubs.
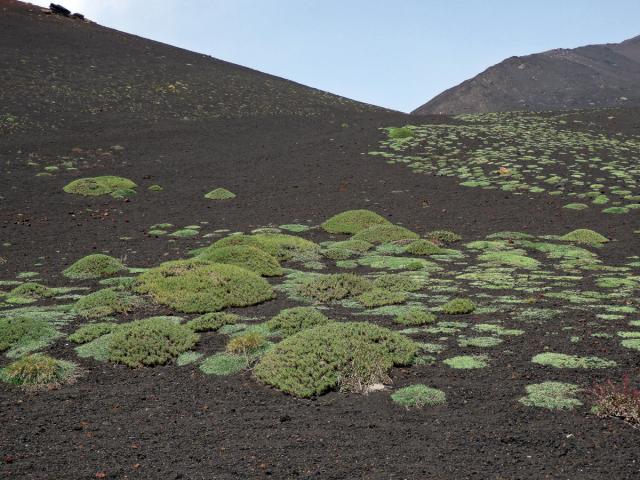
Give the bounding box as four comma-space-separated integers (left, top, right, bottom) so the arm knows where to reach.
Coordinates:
136, 260, 275, 313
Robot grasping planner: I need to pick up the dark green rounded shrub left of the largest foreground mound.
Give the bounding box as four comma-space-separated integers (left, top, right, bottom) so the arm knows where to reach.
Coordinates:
108, 318, 199, 368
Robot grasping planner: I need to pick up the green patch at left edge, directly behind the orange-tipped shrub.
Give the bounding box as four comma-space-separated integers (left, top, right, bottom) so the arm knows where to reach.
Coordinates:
0, 316, 60, 357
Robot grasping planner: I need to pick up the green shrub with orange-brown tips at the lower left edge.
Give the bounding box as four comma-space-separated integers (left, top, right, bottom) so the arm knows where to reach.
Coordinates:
0, 354, 77, 389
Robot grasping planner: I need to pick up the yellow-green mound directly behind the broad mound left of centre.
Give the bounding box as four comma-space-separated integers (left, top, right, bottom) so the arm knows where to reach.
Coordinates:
196, 245, 283, 277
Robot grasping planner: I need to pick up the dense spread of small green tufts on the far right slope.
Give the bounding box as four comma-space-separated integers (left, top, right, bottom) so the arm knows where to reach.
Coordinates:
369, 112, 640, 214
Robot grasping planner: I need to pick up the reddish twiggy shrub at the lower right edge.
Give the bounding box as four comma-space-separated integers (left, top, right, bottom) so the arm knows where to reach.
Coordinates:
589, 375, 640, 425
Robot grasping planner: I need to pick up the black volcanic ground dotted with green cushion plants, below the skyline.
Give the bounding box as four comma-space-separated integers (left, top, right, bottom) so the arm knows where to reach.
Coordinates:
0, 0, 640, 480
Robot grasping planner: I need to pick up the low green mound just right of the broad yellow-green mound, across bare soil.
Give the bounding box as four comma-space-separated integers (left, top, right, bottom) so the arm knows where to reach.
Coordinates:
297, 273, 372, 303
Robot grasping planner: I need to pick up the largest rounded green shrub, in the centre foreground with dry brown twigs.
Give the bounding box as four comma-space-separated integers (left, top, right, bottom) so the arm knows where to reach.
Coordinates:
254, 322, 418, 397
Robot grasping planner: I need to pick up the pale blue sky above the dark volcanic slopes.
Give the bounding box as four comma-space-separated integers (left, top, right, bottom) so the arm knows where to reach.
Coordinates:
31, 0, 640, 112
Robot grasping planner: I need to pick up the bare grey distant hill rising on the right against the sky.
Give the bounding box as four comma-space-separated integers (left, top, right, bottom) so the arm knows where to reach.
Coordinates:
412, 36, 640, 115
